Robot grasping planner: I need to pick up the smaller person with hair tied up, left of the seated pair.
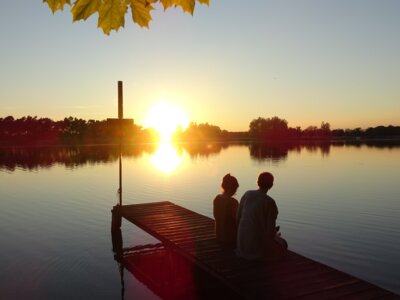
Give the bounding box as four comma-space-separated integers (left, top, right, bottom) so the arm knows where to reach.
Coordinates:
213, 174, 239, 244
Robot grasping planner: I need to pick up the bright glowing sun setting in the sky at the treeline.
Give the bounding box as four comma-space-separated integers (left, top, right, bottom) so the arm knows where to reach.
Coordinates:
144, 102, 189, 141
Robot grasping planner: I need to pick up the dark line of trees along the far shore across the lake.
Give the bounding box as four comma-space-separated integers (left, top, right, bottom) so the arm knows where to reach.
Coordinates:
0, 116, 400, 144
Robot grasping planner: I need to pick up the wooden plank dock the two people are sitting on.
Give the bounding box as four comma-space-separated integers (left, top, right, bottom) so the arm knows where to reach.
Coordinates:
113, 201, 400, 299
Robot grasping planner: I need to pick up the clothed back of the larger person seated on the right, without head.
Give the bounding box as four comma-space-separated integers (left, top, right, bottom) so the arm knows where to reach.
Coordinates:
236, 190, 278, 260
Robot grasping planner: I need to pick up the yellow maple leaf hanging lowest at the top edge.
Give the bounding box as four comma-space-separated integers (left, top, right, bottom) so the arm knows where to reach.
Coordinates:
97, 0, 128, 34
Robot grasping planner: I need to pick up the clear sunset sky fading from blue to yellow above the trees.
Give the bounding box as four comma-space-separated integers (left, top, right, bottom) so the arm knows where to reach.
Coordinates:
0, 0, 400, 131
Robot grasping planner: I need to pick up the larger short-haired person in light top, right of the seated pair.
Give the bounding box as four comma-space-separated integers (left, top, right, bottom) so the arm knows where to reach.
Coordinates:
236, 172, 287, 261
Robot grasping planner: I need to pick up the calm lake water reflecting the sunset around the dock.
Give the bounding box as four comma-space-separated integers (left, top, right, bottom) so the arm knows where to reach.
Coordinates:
0, 144, 400, 299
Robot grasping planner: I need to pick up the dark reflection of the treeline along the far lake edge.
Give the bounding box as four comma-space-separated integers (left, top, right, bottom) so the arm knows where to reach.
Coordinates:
0, 141, 400, 171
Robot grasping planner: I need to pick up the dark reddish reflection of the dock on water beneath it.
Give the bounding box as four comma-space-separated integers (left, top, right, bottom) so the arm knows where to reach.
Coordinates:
111, 221, 241, 300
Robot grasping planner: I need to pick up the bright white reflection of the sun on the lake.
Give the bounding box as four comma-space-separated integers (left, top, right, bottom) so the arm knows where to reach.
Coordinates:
150, 141, 182, 174
